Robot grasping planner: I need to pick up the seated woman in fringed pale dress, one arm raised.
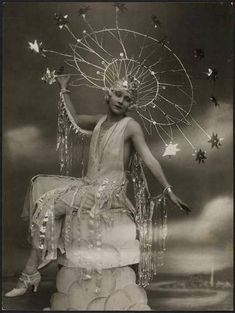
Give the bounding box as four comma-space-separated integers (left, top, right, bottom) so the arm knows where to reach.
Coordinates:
6, 75, 189, 297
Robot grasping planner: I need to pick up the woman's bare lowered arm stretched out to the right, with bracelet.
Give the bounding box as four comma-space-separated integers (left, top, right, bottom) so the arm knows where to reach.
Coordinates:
127, 120, 190, 213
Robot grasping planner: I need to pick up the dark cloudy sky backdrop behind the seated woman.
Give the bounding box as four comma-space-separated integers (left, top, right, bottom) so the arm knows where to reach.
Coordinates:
3, 3, 233, 275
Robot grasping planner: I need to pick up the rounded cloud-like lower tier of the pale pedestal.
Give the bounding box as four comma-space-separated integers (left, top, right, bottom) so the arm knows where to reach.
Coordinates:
51, 266, 151, 311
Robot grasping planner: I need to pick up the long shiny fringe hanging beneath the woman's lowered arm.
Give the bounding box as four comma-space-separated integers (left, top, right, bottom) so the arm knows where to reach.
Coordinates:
131, 154, 167, 287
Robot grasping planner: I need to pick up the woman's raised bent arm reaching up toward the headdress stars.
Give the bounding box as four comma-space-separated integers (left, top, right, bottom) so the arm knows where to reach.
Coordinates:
56, 75, 102, 130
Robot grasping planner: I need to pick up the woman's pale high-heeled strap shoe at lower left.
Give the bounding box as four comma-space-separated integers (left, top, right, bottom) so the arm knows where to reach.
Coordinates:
5, 272, 41, 297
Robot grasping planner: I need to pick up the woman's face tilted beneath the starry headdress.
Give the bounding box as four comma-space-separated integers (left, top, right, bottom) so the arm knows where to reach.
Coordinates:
107, 88, 133, 115
